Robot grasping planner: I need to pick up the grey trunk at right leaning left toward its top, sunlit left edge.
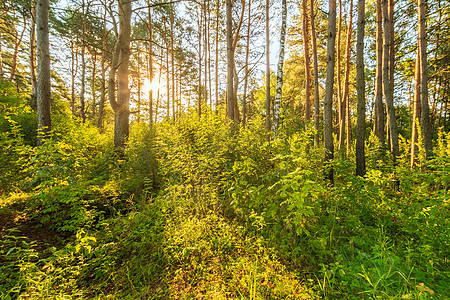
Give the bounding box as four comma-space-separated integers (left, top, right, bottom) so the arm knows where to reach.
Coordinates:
383, 0, 399, 162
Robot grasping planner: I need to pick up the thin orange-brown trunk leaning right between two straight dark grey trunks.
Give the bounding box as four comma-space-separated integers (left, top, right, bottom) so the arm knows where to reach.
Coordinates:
339, 0, 353, 153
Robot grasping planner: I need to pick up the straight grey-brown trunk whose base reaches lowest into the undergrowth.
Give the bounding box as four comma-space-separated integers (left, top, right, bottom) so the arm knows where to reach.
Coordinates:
323, 0, 336, 183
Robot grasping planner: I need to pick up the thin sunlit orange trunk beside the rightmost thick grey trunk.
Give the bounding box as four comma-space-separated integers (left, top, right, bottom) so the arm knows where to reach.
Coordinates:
411, 44, 421, 168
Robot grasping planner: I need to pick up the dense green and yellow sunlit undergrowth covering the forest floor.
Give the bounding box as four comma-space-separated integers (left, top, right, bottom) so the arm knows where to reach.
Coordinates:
0, 107, 450, 299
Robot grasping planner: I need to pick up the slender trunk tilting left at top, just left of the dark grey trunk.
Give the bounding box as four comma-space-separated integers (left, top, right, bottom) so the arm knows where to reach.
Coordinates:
309, 0, 320, 146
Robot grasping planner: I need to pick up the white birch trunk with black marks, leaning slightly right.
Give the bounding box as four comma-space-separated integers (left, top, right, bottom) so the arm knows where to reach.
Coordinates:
272, 0, 286, 134
